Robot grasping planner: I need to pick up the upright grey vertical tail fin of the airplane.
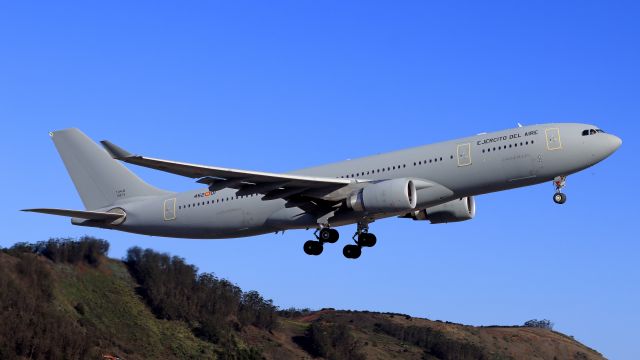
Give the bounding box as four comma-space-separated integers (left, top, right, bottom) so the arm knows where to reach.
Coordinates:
49, 129, 167, 210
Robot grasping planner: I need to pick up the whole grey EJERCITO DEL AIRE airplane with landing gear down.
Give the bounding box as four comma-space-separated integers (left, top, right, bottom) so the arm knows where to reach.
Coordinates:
23, 123, 622, 259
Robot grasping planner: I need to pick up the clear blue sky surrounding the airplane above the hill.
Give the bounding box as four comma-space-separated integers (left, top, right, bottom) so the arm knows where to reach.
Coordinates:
0, 1, 640, 359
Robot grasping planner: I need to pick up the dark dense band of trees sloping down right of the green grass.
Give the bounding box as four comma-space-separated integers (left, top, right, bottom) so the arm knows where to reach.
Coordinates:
126, 247, 277, 343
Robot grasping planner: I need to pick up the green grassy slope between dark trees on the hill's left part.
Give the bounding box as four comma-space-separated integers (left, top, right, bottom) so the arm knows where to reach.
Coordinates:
55, 260, 216, 359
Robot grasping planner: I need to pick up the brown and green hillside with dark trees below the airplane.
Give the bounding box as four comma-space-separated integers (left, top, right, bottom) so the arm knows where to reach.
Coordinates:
0, 238, 603, 360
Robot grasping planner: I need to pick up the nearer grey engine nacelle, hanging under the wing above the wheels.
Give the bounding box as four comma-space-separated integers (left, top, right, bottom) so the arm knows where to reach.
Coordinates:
347, 179, 418, 213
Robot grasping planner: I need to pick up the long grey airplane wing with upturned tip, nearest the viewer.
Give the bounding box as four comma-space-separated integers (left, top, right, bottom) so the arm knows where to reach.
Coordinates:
101, 140, 366, 201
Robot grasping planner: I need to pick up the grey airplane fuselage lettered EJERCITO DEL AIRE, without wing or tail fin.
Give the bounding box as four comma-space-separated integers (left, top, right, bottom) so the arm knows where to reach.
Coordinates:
95, 123, 621, 239
